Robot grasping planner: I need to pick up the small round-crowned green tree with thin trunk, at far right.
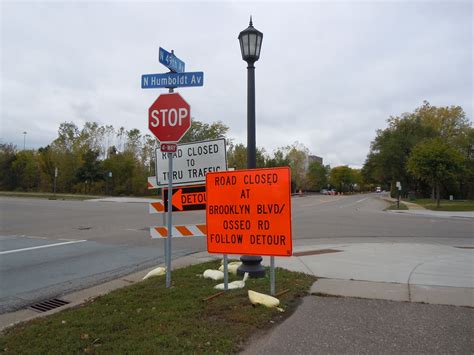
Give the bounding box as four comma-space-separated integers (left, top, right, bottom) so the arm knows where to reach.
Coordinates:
407, 138, 463, 208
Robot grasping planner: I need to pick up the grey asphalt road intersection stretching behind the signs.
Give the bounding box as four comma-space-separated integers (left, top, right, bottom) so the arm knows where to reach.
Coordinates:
0, 194, 472, 313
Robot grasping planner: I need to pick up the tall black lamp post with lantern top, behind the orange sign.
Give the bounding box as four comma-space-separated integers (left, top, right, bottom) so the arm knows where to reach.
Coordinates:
237, 17, 265, 277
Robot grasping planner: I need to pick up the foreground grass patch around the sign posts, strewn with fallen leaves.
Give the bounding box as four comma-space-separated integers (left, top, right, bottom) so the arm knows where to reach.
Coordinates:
0, 261, 316, 354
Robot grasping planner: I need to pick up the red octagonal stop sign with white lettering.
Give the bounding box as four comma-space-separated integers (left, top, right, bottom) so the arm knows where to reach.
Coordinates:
148, 93, 191, 142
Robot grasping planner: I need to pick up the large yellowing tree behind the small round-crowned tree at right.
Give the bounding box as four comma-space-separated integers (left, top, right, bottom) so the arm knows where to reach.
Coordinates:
362, 101, 472, 199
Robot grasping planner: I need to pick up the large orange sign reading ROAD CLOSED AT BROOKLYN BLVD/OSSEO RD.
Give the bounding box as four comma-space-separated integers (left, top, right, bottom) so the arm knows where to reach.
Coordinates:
206, 167, 293, 256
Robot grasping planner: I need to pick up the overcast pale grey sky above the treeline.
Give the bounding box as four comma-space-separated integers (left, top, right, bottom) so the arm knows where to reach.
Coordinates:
0, 0, 473, 167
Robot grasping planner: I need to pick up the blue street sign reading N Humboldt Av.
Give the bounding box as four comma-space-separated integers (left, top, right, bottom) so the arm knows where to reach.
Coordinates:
142, 71, 204, 89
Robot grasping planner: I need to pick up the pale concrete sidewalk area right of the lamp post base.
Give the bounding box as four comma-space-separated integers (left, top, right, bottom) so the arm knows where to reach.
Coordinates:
264, 243, 474, 307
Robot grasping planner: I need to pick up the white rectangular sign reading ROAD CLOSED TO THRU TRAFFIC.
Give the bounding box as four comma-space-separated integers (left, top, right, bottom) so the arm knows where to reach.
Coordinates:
155, 138, 227, 187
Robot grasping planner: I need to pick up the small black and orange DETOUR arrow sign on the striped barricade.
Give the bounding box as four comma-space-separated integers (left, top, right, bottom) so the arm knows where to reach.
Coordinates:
163, 185, 206, 212
